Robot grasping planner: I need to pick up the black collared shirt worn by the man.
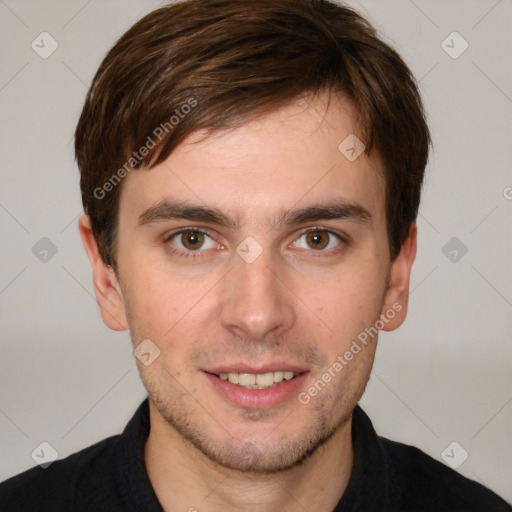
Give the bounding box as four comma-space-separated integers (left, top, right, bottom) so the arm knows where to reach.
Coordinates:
0, 398, 512, 512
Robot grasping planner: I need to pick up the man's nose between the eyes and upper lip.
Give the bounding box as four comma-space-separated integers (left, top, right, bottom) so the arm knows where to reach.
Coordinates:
220, 244, 296, 342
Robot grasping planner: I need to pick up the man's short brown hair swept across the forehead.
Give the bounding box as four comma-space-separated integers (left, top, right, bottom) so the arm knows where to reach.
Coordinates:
75, 0, 431, 269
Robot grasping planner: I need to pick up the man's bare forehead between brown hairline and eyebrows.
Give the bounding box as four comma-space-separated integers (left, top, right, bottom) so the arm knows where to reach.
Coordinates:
120, 95, 385, 225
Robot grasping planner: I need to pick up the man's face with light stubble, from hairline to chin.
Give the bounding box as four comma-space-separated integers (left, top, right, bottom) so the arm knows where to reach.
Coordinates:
98, 97, 412, 472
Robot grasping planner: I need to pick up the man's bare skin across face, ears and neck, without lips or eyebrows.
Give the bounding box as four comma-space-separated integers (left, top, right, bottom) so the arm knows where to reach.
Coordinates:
79, 95, 416, 512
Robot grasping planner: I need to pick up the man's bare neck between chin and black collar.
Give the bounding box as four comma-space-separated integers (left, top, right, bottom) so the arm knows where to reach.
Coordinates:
144, 401, 353, 512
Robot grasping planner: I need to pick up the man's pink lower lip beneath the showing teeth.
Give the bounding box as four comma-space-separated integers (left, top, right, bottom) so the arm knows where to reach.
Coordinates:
204, 372, 308, 409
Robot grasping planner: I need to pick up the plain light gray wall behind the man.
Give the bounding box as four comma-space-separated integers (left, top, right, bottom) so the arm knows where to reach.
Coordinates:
0, 0, 512, 501
